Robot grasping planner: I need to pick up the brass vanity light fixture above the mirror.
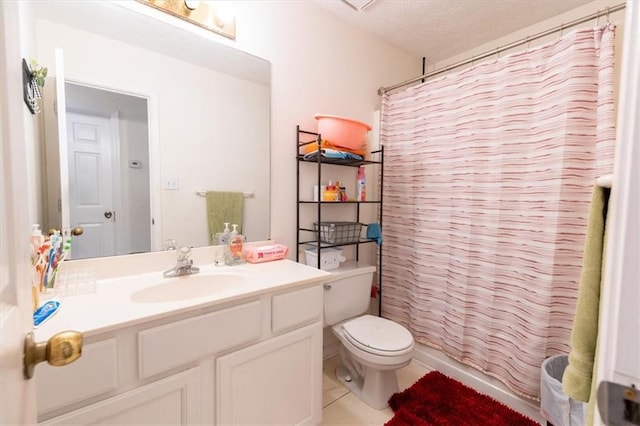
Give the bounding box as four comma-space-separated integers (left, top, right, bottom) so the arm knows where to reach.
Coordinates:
138, 0, 236, 40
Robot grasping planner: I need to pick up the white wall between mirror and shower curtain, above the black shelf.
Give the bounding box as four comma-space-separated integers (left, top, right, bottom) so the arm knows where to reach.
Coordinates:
200, 1, 422, 253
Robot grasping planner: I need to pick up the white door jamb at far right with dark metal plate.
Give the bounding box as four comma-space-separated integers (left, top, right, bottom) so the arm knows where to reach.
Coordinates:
594, 1, 640, 425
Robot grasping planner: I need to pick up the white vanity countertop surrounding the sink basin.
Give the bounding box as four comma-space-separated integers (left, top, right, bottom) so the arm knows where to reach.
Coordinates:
34, 260, 330, 341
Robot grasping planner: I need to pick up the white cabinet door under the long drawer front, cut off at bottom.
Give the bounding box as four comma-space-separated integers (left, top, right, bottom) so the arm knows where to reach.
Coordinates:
40, 367, 200, 425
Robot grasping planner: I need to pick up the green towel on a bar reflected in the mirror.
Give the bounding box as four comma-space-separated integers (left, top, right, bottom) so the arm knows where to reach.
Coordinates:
206, 191, 244, 245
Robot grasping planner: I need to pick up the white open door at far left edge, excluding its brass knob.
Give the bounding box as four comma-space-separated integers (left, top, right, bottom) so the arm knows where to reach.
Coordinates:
0, 2, 36, 425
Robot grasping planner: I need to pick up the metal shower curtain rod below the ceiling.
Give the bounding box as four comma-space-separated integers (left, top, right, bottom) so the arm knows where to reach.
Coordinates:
378, 3, 626, 96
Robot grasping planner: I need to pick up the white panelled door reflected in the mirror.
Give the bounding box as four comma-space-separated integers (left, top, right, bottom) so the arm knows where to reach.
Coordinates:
67, 111, 117, 259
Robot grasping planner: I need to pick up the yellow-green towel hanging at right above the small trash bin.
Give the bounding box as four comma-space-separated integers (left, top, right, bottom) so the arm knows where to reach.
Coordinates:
562, 185, 609, 402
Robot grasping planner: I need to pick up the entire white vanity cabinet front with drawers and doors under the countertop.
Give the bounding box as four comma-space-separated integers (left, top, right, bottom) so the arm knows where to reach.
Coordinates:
35, 283, 322, 425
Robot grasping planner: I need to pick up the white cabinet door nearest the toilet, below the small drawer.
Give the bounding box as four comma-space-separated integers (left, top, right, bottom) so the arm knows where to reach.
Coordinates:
216, 322, 322, 425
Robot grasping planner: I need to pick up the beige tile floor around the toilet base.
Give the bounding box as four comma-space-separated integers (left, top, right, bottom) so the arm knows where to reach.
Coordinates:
322, 356, 429, 426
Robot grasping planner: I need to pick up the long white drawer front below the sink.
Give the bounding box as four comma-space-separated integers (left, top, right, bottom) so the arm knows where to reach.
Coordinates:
138, 301, 262, 379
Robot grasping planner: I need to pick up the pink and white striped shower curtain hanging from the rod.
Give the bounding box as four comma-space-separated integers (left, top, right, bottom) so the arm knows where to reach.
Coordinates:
381, 25, 615, 399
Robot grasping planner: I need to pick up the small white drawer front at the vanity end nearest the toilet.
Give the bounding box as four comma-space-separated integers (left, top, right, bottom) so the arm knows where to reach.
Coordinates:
271, 285, 323, 333
